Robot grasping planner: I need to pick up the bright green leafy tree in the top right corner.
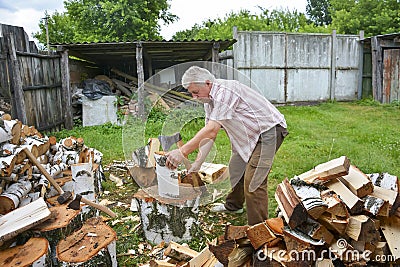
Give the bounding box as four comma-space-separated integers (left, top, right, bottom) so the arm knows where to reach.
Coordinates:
330, 0, 400, 36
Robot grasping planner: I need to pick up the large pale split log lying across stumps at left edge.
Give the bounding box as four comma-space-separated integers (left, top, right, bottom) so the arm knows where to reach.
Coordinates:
0, 198, 51, 245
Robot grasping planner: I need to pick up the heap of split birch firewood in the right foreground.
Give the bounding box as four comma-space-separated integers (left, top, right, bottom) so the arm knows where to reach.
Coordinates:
139, 156, 400, 267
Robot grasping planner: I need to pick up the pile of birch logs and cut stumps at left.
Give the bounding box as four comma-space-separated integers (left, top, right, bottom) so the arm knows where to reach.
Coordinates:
0, 114, 117, 267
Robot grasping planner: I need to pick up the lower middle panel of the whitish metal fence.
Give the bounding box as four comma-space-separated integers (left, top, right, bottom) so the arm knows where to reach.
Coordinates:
287, 69, 330, 102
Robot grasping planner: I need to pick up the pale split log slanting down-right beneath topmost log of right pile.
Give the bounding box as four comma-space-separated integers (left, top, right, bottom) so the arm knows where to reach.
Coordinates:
324, 178, 364, 214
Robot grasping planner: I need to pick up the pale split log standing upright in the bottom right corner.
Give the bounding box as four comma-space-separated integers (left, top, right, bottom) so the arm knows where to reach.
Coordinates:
380, 216, 400, 261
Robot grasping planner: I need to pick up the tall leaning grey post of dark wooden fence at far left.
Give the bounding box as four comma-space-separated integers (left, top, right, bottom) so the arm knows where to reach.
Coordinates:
8, 33, 27, 124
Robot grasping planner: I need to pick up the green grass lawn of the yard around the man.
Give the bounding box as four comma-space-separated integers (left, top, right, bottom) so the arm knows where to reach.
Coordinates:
48, 101, 400, 266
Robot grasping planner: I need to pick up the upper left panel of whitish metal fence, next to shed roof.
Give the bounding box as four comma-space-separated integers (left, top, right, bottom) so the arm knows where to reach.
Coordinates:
233, 32, 285, 69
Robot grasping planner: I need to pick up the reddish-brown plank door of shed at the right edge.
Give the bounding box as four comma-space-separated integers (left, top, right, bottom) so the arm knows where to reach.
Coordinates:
382, 49, 400, 103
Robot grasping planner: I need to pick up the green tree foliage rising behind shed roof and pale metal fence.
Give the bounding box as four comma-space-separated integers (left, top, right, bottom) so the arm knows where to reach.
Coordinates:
173, 8, 330, 40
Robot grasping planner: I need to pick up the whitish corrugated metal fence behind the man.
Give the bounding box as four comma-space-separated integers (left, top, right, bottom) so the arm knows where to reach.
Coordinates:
228, 32, 362, 103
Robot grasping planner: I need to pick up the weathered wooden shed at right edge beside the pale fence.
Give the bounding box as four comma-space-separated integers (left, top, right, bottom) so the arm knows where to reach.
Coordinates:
362, 33, 400, 103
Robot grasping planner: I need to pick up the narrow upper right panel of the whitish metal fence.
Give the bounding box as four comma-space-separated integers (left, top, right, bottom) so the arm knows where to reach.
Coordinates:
336, 35, 361, 69
